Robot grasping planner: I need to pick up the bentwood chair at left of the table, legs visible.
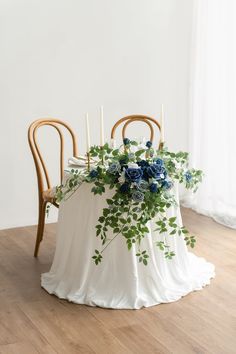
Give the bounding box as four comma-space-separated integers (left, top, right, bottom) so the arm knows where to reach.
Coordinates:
28, 118, 78, 257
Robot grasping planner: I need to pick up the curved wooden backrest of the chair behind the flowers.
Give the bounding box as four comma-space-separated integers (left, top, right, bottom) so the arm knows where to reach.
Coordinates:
111, 114, 161, 146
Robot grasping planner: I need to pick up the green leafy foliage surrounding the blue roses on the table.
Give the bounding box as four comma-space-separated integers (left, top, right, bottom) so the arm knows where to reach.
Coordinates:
56, 141, 202, 265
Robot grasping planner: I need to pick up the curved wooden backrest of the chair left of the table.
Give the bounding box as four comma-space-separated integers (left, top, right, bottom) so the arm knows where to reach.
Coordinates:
28, 118, 78, 193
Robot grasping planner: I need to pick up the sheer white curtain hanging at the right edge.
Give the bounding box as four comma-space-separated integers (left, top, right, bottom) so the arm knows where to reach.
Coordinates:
184, 0, 236, 228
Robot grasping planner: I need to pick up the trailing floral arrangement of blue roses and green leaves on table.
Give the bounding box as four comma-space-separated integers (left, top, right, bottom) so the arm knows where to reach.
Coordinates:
56, 138, 202, 265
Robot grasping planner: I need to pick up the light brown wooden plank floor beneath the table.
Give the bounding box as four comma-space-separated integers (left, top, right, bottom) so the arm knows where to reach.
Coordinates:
0, 209, 236, 354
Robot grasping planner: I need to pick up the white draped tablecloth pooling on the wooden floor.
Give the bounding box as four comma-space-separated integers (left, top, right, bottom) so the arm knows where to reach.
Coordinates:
41, 184, 214, 309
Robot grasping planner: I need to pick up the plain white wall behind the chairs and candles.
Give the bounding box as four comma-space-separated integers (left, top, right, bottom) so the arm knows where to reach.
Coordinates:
0, 0, 192, 229
